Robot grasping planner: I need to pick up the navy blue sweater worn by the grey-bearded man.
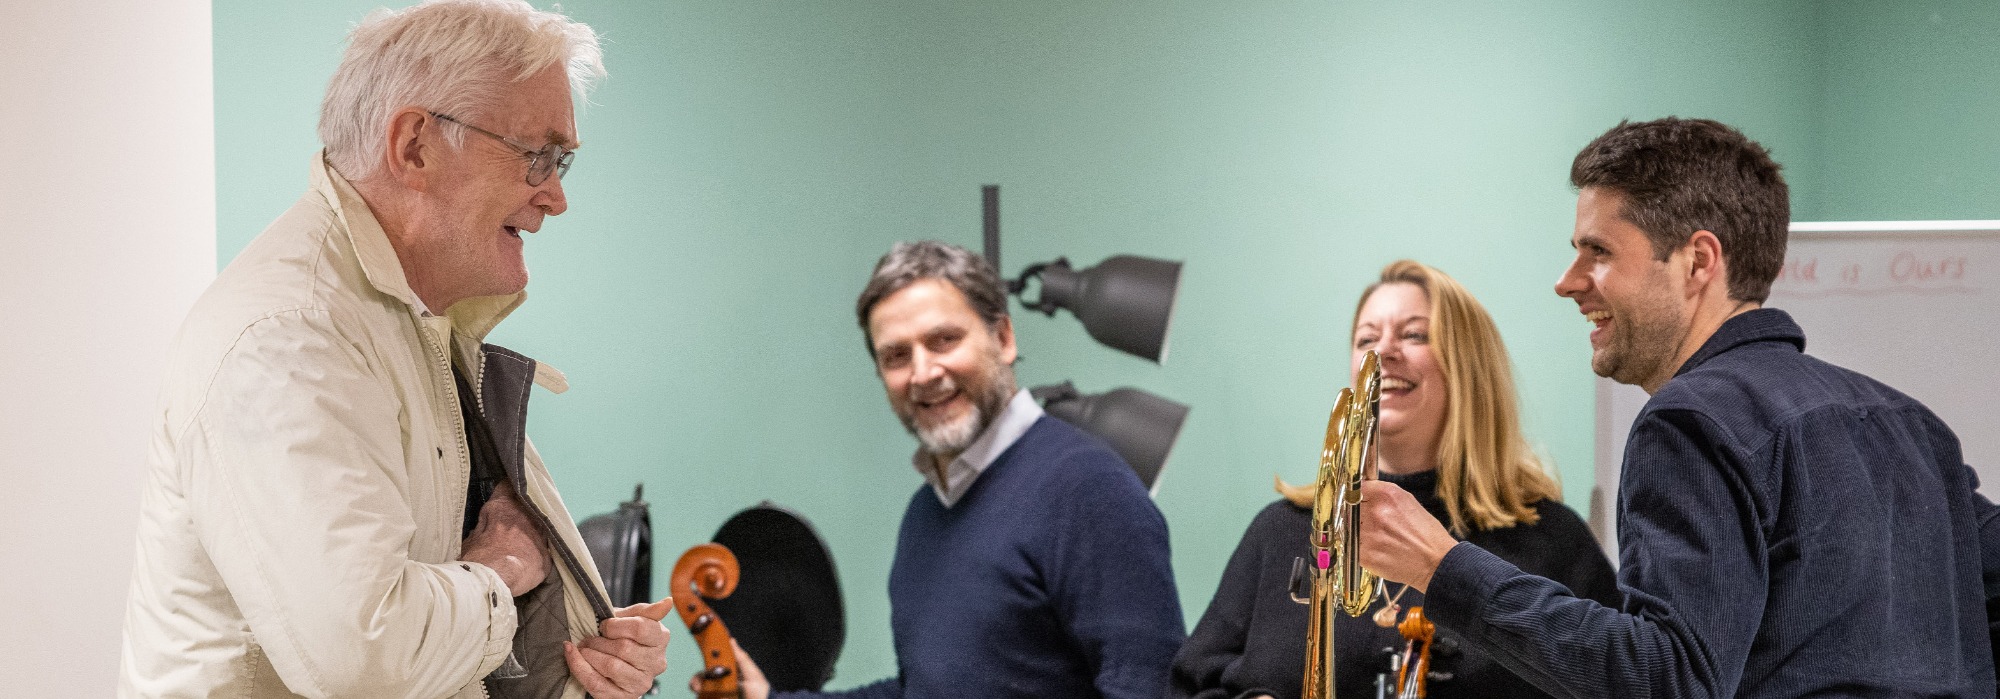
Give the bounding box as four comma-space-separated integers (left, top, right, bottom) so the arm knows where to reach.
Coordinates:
784, 415, 1186, 699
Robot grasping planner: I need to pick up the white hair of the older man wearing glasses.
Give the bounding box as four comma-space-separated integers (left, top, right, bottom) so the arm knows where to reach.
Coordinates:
320, 0, 604, 180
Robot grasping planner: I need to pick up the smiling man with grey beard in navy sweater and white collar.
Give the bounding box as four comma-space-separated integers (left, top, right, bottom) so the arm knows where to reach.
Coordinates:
738, 242, 1186, 699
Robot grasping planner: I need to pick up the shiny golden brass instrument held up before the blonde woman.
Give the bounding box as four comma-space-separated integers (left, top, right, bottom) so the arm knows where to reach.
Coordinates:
1292, 350, 1382, 699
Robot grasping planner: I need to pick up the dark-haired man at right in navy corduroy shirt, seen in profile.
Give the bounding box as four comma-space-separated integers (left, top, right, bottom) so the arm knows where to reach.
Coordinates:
1362, 118, 2000, 697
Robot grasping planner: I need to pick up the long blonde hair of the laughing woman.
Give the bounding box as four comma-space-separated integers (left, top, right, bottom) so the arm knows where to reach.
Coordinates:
1278, 260, 1562, 535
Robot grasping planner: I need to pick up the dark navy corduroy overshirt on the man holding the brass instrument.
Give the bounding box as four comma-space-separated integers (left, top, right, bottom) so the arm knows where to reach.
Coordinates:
1428, 310, 2000, 699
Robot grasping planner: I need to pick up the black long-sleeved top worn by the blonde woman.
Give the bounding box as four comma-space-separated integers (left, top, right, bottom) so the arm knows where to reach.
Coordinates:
1168, 471, 1620, 699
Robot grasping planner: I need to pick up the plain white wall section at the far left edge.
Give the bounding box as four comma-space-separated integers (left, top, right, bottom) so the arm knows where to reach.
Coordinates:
0, 0, 216, 697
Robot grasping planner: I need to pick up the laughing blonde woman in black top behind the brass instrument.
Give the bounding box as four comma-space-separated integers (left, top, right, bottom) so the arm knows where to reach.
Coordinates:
1168, 260, 1618, 699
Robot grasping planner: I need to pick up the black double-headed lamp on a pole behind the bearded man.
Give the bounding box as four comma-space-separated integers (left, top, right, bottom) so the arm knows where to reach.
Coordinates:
980, 184, 1188, 491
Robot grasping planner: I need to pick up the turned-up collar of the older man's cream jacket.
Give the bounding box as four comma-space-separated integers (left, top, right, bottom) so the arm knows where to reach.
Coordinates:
312, 150, 528, 340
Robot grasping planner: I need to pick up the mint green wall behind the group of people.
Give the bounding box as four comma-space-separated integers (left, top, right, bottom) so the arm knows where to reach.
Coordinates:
214, 0, 1994, 687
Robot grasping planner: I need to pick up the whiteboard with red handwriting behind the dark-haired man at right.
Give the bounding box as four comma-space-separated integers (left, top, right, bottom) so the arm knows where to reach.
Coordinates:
1590, 220, 2000, 561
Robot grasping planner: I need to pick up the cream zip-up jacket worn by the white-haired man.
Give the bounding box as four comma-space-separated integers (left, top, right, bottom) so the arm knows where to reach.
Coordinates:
120, 158, 610, 697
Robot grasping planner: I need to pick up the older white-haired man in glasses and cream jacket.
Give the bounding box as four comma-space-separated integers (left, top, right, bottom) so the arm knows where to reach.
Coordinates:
120, 0, 666, 699
